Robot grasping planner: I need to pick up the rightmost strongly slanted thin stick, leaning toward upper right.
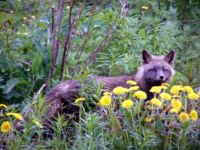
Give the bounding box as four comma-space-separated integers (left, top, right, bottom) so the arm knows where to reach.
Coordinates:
85, 1, 135, 68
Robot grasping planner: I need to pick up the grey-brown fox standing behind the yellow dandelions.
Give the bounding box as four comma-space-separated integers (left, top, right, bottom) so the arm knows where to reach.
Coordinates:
42, 50, 175, 119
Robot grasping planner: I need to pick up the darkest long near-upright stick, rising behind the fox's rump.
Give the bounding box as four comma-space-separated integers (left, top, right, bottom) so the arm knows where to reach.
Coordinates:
59, 0, 74, 81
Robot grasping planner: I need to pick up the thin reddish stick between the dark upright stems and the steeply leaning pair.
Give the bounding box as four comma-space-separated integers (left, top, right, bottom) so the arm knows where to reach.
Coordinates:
72, 0, 99, 77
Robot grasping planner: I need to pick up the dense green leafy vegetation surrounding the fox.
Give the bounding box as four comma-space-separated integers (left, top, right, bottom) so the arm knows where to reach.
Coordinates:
0, 0, 200, 149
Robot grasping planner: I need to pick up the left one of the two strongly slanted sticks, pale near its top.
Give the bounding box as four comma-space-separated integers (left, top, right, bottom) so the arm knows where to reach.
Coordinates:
85, 0, 128, 68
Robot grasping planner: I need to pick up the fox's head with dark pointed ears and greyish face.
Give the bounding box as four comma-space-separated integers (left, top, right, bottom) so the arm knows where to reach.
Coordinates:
136, 50, 175, 86
